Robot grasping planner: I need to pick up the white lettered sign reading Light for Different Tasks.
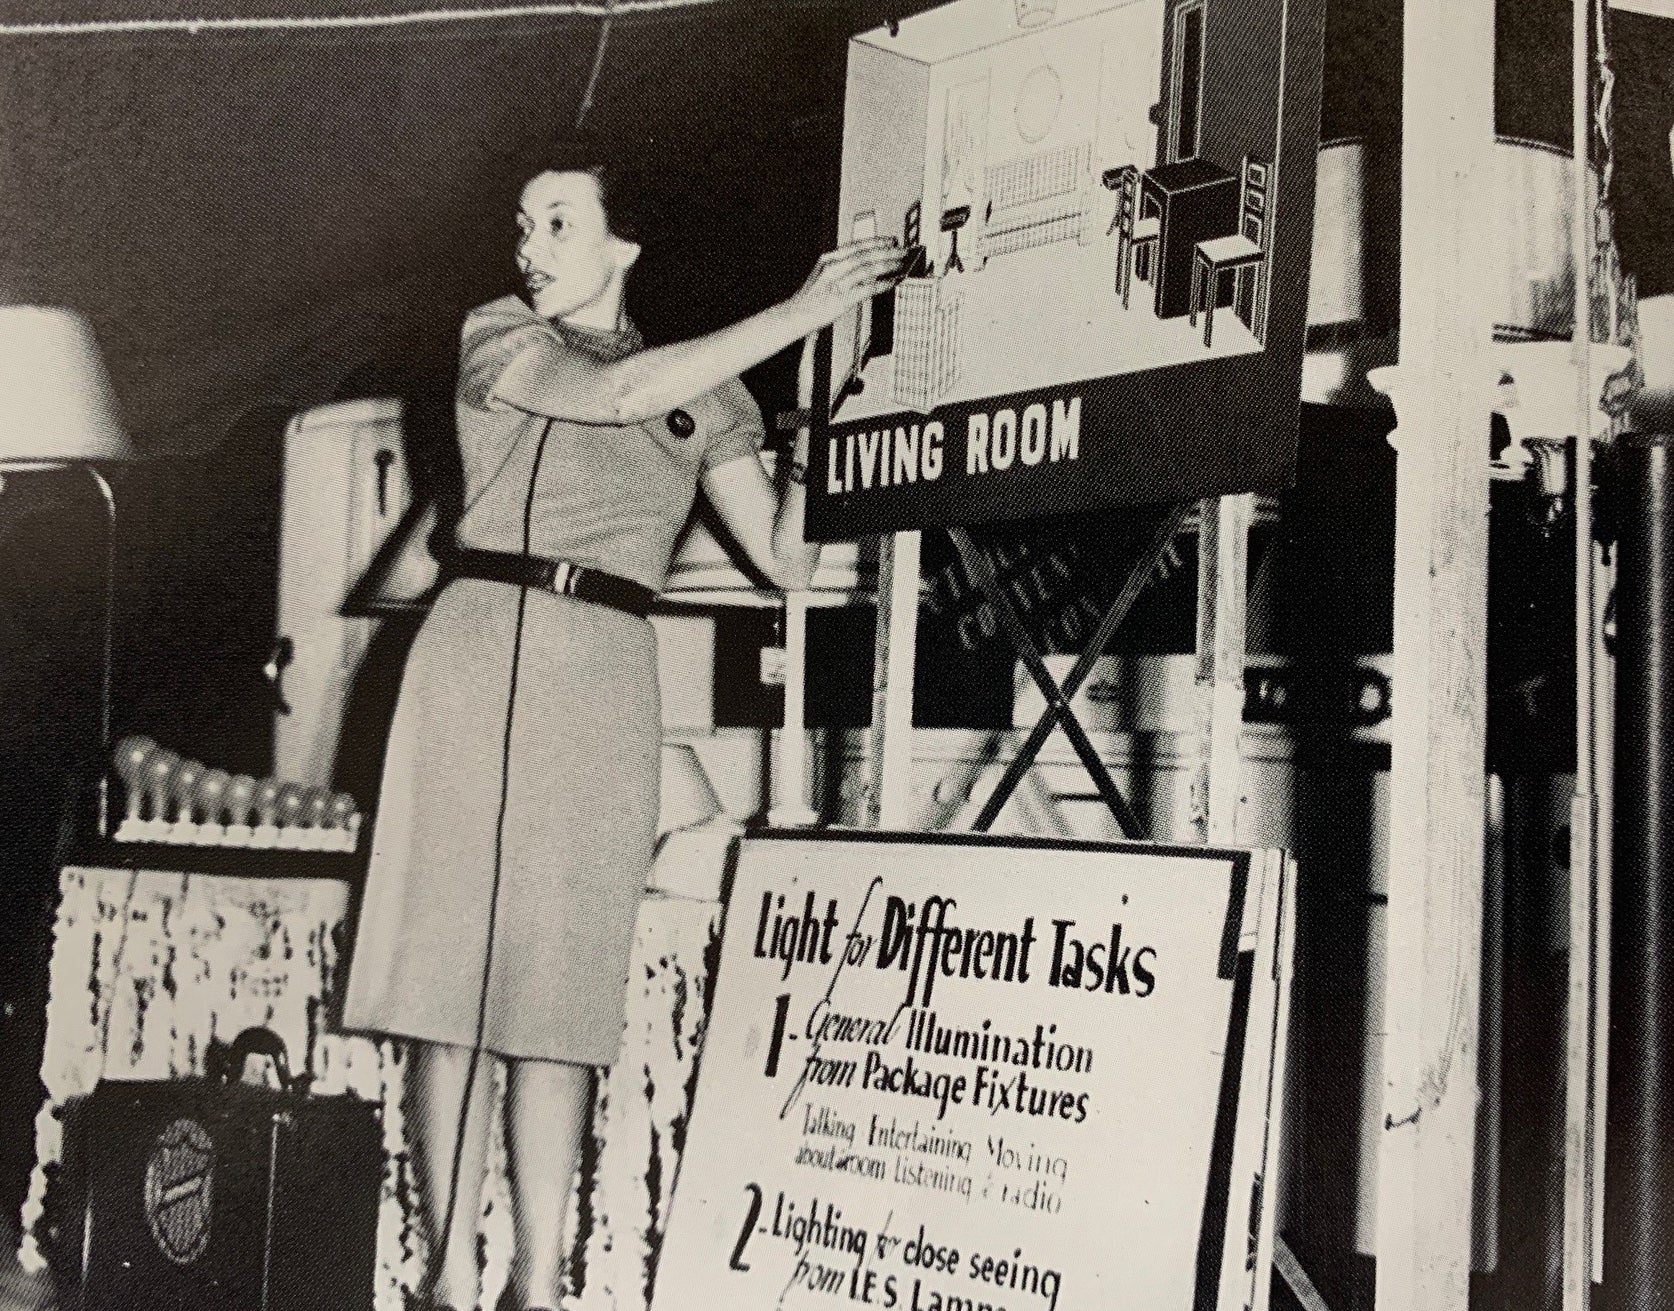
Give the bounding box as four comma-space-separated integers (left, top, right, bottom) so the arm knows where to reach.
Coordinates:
653, 834, 1287, 1311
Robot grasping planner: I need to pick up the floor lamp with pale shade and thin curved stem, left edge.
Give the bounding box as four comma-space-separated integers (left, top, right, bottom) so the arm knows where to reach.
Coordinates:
0, 305, 137, 835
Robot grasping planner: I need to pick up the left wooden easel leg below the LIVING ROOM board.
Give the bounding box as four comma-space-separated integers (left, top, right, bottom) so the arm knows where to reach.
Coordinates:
864, 532, 921, 829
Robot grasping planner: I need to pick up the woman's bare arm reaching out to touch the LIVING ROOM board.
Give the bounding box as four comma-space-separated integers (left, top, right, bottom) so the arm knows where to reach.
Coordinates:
490, 238, 902, 424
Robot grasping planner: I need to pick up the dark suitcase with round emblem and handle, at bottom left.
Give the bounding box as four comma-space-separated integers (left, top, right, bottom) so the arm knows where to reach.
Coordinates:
66, 1030, 383, 1311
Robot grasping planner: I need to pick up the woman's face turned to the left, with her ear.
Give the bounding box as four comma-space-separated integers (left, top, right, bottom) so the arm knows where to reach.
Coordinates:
517, 172, 639, 326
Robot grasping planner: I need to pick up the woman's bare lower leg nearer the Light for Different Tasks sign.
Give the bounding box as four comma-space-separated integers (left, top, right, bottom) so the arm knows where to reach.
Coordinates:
506, 1060, 593, 1311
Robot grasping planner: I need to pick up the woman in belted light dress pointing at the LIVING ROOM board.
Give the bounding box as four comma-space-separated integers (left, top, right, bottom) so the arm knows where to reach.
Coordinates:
345, 156, 901, 1308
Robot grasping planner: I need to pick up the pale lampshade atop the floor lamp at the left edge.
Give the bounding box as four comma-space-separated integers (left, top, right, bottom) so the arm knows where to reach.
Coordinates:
0, 305, 137, 469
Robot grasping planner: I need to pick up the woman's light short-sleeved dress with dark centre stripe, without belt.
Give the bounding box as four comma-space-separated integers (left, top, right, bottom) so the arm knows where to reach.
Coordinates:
343, 296, 763, 1065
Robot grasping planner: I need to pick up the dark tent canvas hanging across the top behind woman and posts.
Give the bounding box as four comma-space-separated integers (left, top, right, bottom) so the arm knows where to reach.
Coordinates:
0, 0, 1647, 457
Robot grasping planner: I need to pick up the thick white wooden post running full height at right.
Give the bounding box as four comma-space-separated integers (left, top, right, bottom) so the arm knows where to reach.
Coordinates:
1376, 0, 1495, 1311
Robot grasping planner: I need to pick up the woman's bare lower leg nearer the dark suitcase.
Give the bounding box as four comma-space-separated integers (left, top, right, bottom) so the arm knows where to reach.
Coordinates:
408, 1041, 496, 1309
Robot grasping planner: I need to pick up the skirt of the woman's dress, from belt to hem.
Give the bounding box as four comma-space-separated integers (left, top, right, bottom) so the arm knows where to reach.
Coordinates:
343, 579, 661, 1065
